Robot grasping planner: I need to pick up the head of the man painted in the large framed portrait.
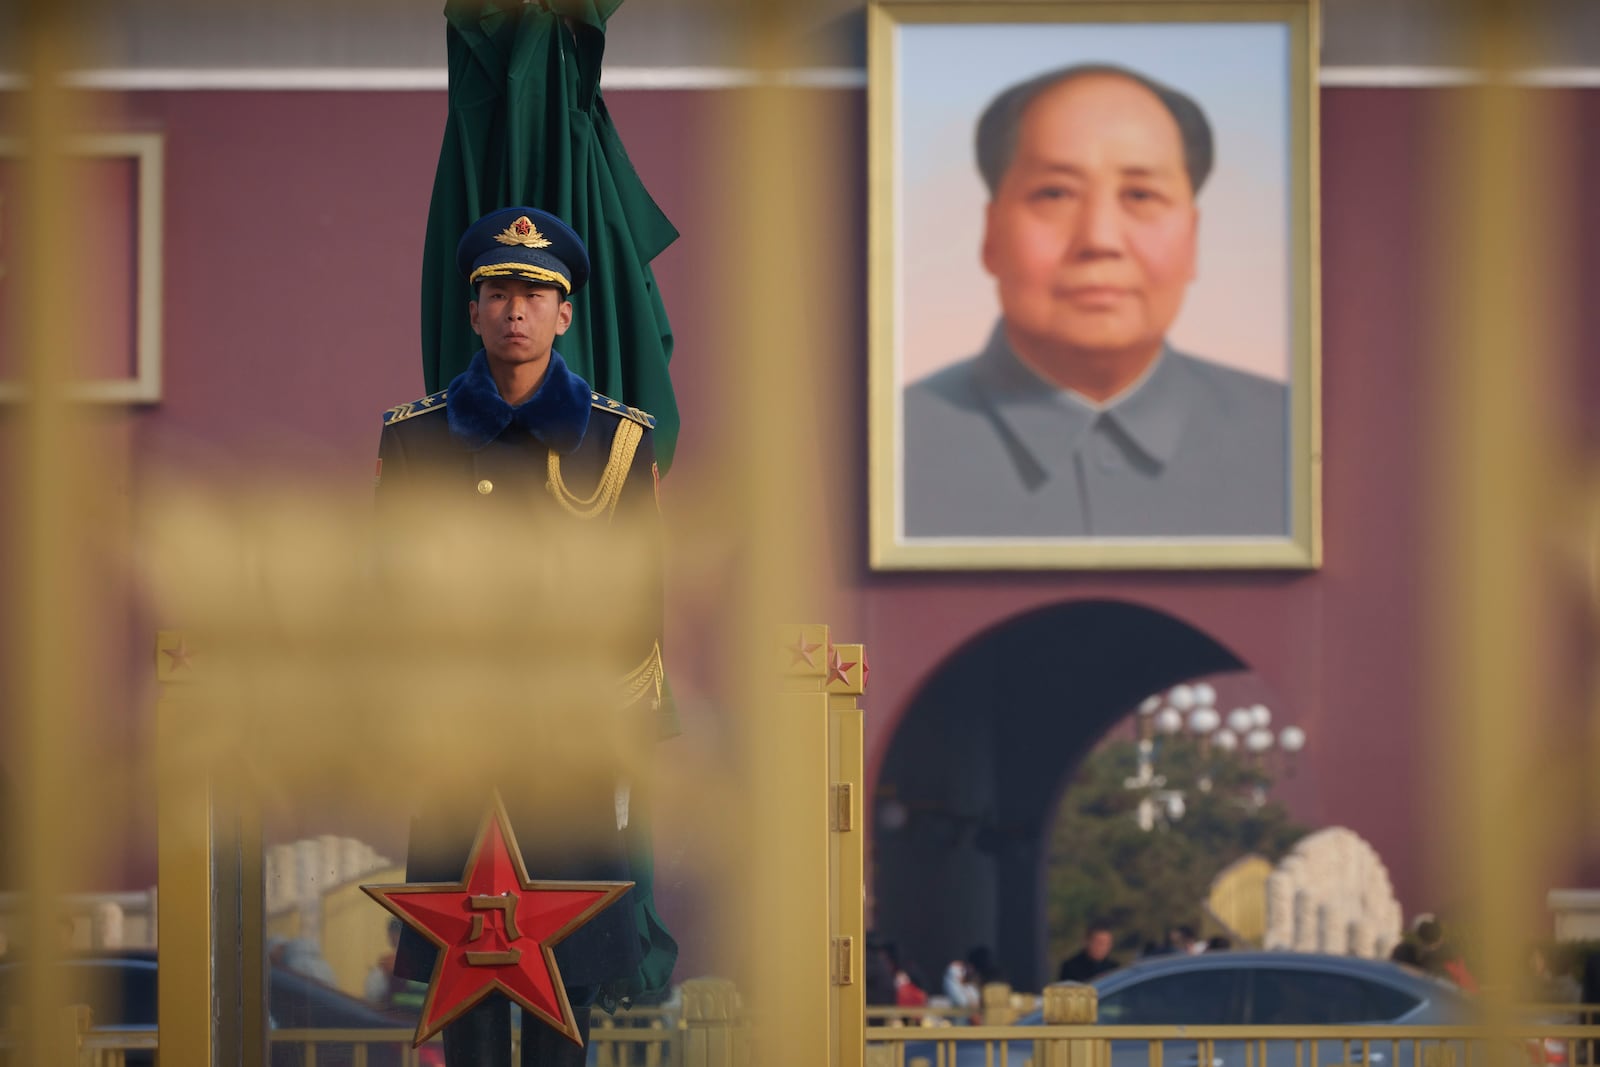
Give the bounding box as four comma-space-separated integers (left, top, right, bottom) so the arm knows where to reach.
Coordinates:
982, 75, 1198, 367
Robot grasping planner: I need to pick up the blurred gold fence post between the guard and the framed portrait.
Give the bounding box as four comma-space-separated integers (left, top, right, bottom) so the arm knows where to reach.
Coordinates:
709, 0, 864, 1067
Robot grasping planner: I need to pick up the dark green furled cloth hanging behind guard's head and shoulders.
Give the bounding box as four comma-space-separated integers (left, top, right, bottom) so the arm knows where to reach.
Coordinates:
422, 0, 678, 470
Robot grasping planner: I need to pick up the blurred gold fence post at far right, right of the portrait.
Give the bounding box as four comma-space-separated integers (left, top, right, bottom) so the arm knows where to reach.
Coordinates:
1429, 0, 1563, 1025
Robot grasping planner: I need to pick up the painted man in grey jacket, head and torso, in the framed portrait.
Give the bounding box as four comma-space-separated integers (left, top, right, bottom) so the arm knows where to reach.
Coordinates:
902, 64, 1290, 537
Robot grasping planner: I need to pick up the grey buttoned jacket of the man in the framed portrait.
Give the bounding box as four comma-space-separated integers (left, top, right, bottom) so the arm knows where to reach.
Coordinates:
901, 323, 1290, 537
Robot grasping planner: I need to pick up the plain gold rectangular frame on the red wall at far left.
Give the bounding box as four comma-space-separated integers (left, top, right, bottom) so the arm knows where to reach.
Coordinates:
0, 133, 166, 403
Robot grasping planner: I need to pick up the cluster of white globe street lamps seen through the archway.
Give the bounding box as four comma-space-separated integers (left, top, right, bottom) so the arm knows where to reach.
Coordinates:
1123, 681, 1306, 830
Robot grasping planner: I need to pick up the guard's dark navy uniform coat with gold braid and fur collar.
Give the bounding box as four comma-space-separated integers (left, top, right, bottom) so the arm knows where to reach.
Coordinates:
378, 350, 677, 995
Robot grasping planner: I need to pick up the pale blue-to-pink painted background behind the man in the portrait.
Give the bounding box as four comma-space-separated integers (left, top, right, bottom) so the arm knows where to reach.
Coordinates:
894, 22, 1291, 384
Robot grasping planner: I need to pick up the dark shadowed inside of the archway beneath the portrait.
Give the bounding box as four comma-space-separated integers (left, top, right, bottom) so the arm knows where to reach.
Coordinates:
874, 600, 1246, 989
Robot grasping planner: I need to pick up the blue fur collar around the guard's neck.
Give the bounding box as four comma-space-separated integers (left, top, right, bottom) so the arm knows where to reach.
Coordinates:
445, 349, 592, 456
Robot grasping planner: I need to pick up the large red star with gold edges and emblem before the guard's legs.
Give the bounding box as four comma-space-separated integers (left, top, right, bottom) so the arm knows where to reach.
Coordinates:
362, 793, 634, 1045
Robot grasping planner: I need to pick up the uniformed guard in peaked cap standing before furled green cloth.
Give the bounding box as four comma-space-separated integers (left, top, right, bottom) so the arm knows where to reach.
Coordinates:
378, 206, 677, 1067
